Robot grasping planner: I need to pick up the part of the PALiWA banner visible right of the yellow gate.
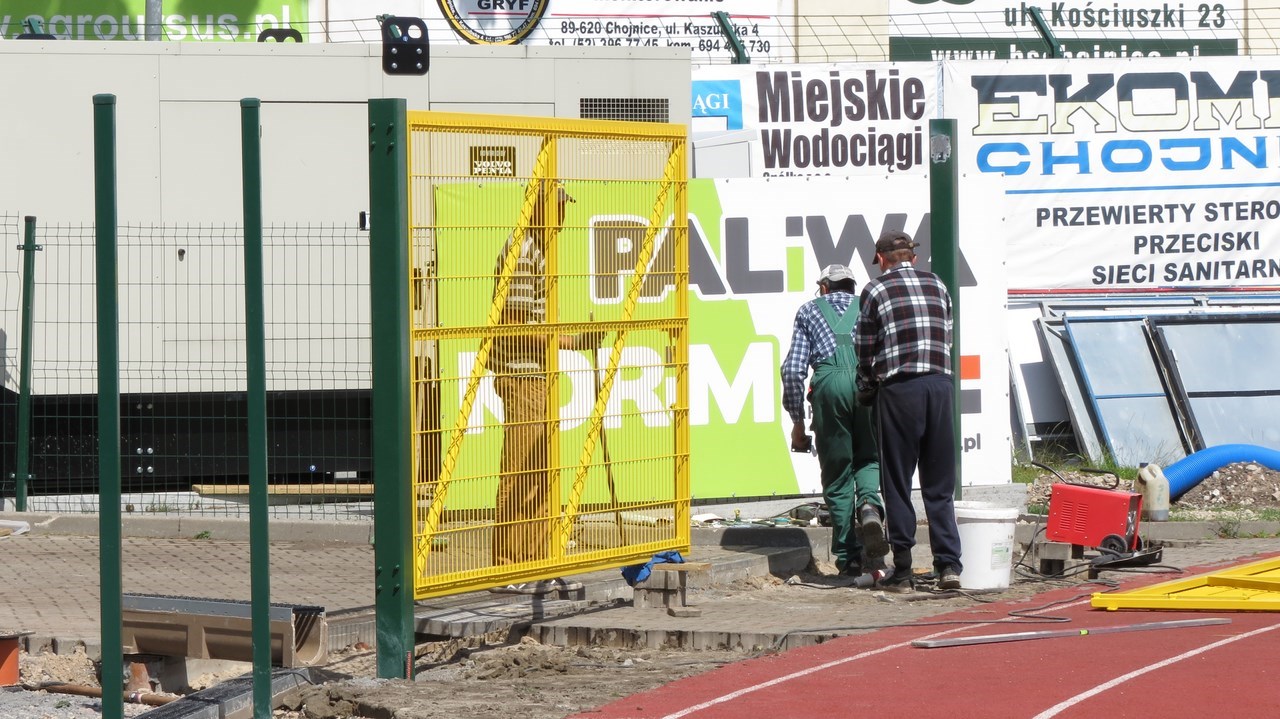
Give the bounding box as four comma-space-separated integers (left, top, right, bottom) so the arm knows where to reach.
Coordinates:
689, 174, 1010, 488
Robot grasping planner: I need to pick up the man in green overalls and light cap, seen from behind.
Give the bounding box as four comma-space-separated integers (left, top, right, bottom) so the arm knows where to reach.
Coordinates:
782, 265, 888, 576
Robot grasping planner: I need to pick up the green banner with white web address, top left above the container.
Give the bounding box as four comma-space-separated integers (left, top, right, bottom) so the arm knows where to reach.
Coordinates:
0, 0, 307, 42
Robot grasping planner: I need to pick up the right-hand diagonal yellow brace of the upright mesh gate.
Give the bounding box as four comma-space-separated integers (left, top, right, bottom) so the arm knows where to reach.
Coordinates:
558, 142, 686, 550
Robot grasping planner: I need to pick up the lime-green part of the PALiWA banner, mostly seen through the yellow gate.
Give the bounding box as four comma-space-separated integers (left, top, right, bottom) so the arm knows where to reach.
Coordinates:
435, 180, 800, 509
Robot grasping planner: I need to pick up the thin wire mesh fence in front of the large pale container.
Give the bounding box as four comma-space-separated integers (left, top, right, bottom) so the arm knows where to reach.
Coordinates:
5, 224, 372, 518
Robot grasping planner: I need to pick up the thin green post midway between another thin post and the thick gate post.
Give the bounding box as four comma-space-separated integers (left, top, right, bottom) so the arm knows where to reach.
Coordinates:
241, 97, 273, 719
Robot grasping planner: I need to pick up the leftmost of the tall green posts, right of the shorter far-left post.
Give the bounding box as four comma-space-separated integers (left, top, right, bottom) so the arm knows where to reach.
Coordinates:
93, 95, 124, 719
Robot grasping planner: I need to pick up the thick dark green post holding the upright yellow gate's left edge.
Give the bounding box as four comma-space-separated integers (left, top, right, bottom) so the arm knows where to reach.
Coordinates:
369, 99, 413, 679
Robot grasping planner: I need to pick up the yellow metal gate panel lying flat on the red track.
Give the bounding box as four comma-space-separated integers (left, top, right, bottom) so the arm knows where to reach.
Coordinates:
1093, 550, 1280, 612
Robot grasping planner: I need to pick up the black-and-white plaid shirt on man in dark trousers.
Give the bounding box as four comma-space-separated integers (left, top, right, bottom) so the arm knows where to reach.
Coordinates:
854, 262, 951, 389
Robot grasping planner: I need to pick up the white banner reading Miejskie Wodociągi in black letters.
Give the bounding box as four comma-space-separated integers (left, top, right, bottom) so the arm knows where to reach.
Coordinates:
692, 63, 937, 177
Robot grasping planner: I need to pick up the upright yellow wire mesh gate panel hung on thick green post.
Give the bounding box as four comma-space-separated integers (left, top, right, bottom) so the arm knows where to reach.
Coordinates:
410, 113, 690, 597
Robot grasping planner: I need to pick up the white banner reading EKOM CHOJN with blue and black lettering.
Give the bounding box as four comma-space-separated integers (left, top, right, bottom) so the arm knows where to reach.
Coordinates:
945, 58, 1280, 292
